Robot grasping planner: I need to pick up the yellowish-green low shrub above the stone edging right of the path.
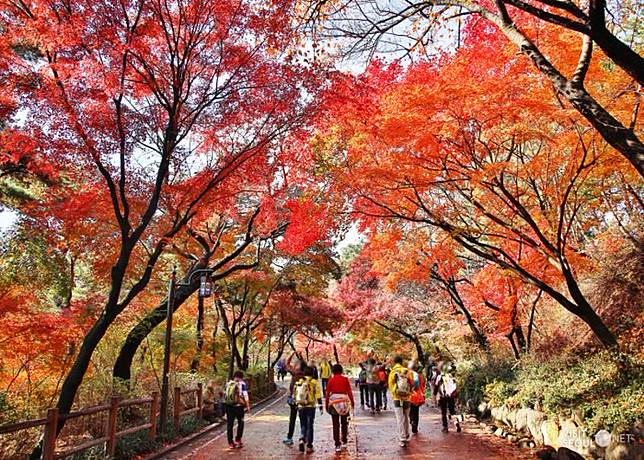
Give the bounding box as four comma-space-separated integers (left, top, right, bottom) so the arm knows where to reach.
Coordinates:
460, 351, 644, 432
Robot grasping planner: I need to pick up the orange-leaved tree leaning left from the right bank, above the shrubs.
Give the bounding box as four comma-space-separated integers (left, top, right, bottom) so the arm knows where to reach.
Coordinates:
314, 26, 632, 347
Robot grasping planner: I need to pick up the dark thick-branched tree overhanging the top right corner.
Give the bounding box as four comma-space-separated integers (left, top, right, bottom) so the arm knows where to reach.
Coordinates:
304, 0, 644, 175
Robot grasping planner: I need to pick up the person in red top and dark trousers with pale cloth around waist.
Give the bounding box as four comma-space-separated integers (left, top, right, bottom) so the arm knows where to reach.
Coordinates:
324, 364, 354, 452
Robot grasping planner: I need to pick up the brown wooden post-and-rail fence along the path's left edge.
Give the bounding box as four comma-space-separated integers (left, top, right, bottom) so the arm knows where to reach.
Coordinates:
0, 383, 203, 460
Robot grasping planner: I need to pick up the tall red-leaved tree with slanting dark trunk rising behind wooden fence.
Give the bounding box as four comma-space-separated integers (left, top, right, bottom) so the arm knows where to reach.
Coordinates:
2, 0, 317, 454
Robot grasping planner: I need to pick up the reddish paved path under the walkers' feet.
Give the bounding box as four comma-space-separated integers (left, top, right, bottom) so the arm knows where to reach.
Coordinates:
164, 382, 534, 460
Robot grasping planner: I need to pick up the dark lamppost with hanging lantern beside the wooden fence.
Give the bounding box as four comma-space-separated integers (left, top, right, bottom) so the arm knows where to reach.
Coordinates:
159, 267, 214, 433
